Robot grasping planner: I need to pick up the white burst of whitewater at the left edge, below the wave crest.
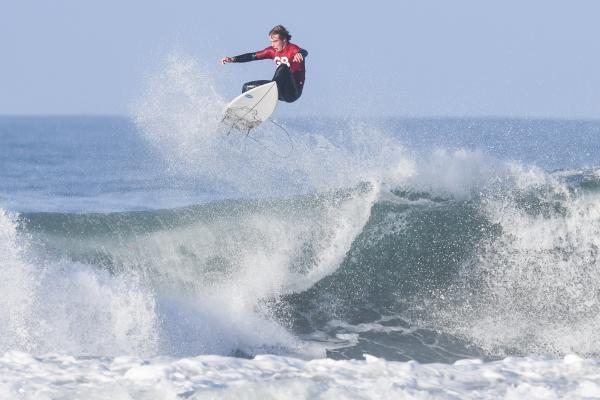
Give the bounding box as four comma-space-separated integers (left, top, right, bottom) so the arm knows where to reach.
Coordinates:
0, 211, 158, 354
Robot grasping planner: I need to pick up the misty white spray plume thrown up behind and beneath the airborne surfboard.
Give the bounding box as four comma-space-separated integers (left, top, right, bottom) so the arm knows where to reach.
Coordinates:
132, 54, 414, 197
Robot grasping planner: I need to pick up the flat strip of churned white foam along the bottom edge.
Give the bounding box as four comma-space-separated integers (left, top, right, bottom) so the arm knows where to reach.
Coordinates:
0, 352, 600, 400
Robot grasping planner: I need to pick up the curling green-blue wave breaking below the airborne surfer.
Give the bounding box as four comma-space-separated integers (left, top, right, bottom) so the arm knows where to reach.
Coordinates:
5, 161, 600, 361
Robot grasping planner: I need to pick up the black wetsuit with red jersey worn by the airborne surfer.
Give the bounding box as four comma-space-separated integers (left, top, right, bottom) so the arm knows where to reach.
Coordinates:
233, 43, 308, 103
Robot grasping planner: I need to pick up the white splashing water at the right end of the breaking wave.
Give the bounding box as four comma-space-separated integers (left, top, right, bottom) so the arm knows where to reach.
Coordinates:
434, 164, 600, 356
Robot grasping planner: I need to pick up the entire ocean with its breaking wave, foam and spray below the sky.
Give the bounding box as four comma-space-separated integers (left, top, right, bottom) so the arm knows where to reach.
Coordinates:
0, 59, 600, 399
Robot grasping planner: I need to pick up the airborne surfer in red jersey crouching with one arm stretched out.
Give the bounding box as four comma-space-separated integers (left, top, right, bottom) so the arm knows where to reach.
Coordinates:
221, 25, 308, 103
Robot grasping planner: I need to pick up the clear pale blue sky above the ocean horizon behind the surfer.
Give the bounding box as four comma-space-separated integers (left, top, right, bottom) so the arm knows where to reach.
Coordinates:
0, 0, 600, 118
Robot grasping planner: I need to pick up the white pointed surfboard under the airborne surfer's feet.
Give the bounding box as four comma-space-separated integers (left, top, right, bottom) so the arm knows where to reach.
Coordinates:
222, 82, 278, 131
